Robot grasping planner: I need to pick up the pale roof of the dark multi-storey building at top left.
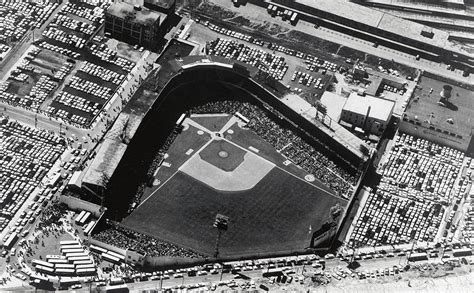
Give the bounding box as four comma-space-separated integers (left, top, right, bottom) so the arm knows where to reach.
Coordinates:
107, 2, 166, 25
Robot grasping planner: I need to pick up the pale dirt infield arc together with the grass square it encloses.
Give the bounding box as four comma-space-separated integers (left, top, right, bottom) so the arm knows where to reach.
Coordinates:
180, 138, 275, 191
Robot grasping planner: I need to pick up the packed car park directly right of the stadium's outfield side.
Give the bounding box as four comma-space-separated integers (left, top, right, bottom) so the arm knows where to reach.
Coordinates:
349, 134, 471, 246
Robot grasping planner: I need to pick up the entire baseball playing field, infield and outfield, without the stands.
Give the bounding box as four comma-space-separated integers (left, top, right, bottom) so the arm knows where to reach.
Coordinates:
122, 113, 347, 257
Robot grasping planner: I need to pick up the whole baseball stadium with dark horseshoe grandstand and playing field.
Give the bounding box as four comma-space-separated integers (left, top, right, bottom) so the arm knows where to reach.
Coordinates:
98, 56, 367, 258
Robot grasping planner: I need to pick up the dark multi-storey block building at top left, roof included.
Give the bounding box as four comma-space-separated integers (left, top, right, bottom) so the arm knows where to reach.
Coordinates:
105, 2, 167, 50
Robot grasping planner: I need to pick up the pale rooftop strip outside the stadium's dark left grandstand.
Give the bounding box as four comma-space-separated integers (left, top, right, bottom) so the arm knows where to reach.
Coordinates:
82, 138, 127, 186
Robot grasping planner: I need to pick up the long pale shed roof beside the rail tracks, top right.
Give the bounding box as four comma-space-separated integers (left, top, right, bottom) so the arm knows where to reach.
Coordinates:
294, 0, 470, 55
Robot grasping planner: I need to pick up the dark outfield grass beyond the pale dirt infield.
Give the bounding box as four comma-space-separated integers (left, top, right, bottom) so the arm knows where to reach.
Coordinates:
123, 168, 345, 257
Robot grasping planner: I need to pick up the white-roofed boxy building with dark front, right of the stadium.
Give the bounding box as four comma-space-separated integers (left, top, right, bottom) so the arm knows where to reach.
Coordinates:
339, 92, 395, 135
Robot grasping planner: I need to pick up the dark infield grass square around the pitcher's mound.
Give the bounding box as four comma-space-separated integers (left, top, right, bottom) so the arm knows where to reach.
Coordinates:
199, 140, 245, 172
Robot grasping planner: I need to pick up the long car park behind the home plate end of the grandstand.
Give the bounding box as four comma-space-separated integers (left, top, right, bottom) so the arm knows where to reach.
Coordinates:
187, 21, 341, 102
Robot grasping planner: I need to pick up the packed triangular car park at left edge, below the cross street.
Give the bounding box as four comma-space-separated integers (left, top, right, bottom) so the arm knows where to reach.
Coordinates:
0, 117, 65, 240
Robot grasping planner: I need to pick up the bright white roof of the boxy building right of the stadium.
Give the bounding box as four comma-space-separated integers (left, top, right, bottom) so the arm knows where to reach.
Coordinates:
343, 92, 394, 121
